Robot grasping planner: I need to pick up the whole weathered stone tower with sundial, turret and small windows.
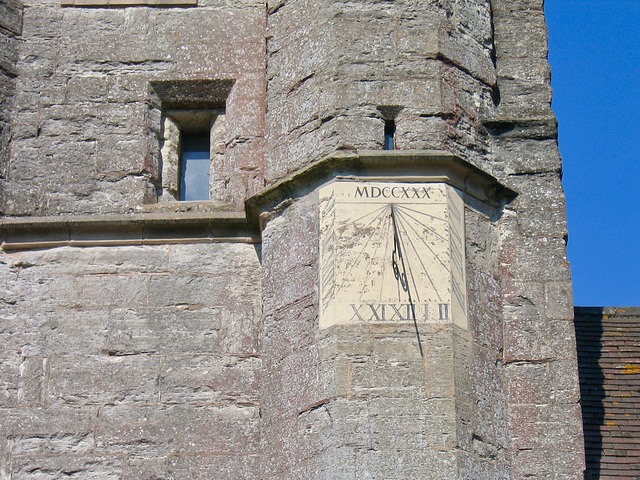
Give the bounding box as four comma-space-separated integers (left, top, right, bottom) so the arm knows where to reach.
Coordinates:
0, 0, 584, 480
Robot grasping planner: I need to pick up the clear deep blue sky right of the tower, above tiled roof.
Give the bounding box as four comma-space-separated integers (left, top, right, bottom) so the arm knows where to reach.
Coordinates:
545, 0, 640, 307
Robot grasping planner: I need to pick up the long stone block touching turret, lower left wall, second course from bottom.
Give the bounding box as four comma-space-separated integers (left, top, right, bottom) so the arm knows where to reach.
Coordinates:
96, 405, 258, 455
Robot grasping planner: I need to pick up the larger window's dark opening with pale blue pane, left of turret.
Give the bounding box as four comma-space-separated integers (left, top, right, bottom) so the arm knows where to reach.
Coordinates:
180, 132, 211, 201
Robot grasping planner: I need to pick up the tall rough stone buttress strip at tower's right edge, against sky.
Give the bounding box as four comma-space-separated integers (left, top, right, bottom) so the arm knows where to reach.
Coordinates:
485, 0, 584, 478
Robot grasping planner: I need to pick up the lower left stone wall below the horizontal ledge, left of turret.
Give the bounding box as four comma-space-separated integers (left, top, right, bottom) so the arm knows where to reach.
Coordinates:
0, 243, 261, 479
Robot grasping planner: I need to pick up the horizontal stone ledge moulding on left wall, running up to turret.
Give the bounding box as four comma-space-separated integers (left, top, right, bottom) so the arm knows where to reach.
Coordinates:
0, 212, 260, 251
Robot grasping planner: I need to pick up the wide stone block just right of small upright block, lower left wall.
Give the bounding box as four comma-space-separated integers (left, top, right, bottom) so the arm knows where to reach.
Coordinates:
49, 355, 160, 405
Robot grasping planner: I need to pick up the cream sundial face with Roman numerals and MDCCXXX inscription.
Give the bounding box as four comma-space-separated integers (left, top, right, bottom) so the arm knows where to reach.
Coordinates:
319, 181, 466, 328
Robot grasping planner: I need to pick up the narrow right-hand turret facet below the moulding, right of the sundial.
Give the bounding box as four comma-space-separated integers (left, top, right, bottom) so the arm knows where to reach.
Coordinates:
453, 195, 510, 478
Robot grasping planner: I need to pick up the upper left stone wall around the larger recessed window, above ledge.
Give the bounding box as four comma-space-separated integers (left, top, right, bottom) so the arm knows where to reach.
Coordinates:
0, 0, 265, 215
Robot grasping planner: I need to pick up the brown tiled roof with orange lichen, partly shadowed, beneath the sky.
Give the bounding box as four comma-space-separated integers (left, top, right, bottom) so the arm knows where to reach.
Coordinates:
575, 307, 640, 480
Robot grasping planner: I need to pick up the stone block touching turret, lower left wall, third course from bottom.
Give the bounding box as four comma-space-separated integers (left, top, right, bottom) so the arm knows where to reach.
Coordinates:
160, 355, 261, 405
